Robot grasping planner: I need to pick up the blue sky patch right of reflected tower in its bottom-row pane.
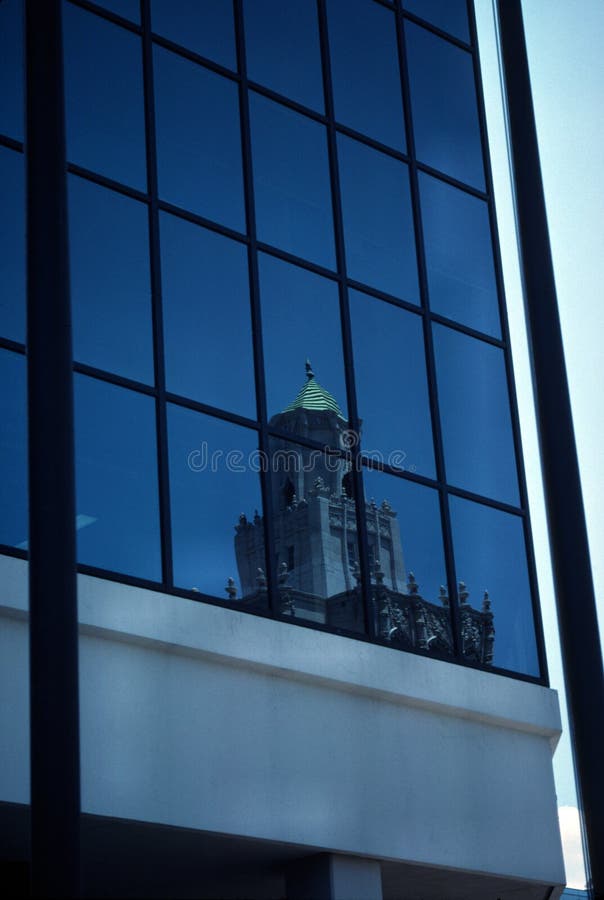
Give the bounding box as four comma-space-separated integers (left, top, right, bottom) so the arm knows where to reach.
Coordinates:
363, 469, 447, 605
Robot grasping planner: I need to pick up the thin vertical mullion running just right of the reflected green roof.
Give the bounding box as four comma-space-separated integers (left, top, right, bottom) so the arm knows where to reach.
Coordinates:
317, 0, 376, 638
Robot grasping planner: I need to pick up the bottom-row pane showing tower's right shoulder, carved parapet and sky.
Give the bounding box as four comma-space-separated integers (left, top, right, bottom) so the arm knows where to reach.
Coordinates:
363, 470, 453, 656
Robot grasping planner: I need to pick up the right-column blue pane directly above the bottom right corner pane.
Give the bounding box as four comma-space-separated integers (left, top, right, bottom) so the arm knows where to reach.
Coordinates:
434, 325, 519, 505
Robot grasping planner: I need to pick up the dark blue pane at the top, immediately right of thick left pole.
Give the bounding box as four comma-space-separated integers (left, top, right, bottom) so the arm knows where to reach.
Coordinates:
63, 3, 146, 191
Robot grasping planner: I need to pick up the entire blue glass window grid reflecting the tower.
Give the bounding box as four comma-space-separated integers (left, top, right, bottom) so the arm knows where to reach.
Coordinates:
0, 0, 544, 679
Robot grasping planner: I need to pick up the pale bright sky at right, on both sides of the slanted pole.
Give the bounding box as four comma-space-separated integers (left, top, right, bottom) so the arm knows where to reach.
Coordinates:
476, 0, 604, 886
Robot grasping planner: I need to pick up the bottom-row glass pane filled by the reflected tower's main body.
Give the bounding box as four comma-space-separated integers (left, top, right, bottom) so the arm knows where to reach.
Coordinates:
271, 438, 364, 631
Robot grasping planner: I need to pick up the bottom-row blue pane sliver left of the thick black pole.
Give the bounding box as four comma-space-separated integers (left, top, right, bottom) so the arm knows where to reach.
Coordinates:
0, 350, 28, 550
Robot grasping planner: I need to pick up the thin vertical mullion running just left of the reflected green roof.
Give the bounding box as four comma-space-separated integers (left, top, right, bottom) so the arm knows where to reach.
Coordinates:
233, 0, 281, 616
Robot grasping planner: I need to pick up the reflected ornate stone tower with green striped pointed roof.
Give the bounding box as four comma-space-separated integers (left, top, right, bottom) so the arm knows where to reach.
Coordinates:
234, 361, 495, 665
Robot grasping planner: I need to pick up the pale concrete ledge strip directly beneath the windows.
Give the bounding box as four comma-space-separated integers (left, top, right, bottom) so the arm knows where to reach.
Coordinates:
0, 557, 561, 751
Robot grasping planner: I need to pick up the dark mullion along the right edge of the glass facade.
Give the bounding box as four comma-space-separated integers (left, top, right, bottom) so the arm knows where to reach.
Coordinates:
467, 0, 549, 684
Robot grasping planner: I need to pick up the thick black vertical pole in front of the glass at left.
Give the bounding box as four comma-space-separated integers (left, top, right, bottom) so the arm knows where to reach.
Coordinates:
25, 0, 80, 897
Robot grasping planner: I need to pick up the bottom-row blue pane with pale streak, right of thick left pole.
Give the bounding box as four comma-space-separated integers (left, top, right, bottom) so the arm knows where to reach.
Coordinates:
74, 374, 161, 581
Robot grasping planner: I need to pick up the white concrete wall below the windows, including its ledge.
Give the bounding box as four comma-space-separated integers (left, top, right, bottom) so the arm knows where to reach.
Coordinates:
0, 559, 564, 884
